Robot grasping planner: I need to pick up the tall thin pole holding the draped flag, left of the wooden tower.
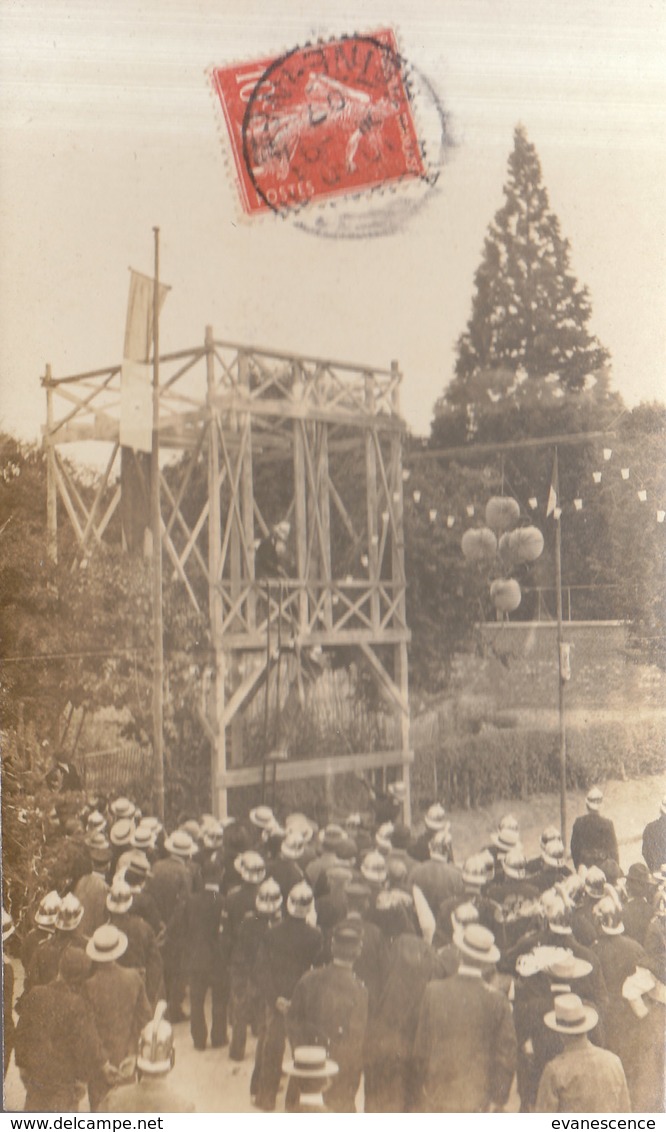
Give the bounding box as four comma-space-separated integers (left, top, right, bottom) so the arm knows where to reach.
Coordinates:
151, 228, 164, 821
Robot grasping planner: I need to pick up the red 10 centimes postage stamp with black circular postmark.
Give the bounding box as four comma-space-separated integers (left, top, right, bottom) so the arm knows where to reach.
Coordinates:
212, 29, 426, 215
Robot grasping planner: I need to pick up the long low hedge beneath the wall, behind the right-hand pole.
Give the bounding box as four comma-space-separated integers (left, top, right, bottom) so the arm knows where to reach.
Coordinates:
412, 719, 666, 811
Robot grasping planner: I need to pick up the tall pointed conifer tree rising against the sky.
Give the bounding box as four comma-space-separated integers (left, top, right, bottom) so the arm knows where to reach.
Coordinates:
444, 126, 608, 405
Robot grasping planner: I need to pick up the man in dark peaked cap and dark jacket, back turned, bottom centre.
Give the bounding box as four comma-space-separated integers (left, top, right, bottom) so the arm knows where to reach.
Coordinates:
285, 923, 368, 1113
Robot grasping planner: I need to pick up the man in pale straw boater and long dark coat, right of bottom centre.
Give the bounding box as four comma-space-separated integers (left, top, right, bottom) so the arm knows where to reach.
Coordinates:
413, 924, 516, 1113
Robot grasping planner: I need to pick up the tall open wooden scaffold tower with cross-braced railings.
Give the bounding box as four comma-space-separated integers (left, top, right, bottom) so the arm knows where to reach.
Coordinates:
42, 327, 412, 820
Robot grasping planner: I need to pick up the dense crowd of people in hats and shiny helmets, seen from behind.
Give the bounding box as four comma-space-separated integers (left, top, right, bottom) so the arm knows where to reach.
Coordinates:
2, 781, 666, 1113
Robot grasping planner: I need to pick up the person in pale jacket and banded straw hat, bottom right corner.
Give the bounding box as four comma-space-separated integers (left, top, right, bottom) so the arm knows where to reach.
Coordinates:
535, 994, 631, 1113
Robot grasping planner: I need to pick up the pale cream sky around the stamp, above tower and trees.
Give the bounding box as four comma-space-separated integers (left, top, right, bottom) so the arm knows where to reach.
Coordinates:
0, 0, 666, 452
